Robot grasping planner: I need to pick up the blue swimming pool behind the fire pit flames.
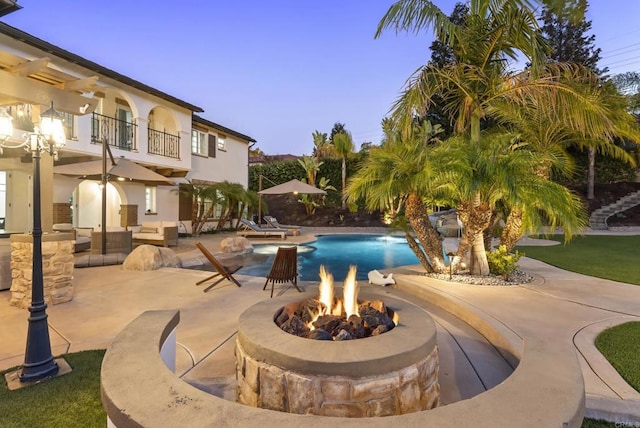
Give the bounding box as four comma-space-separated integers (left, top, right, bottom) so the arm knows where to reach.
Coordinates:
237, 235, 419, 283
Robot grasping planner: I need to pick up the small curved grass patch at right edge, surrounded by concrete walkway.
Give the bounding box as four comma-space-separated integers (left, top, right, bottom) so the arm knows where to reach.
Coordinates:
596, 321, 640, 392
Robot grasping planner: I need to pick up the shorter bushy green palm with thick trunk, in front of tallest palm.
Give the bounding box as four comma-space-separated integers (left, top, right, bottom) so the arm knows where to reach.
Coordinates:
432, 131, 586, 275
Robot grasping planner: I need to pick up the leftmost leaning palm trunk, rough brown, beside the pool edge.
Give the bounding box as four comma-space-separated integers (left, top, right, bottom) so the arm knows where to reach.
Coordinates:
406, 194, 449, 273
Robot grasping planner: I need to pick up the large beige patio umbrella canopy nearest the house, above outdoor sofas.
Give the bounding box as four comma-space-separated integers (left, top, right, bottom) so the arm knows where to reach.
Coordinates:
53, 158, 175, 186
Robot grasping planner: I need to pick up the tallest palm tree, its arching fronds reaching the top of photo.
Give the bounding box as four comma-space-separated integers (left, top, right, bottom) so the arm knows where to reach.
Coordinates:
376, 0, 636, 274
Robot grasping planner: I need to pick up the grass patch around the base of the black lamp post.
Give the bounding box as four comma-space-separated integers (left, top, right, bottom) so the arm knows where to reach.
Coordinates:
0, 350, 107, 428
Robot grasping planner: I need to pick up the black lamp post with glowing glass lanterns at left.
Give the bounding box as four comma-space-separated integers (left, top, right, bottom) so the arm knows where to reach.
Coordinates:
0, 102, 66, 382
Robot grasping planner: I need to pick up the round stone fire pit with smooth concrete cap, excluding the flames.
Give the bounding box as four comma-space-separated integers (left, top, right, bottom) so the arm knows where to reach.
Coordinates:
236, 287, 440, 417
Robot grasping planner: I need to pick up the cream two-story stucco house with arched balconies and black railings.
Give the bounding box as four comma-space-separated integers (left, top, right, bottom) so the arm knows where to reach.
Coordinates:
0, 22, 255, 237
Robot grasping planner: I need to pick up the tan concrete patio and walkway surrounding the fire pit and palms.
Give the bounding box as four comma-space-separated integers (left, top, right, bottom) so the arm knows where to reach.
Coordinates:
0, 229, 640, 423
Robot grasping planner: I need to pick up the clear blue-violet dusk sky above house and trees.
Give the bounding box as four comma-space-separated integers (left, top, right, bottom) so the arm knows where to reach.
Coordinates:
2, 0, 640, 155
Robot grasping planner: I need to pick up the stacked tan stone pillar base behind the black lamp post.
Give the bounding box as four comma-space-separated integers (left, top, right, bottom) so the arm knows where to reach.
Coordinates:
9, 233, 75, 309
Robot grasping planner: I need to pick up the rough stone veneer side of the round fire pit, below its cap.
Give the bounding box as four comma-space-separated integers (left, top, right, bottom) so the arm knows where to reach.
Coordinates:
236, 342, 440, 418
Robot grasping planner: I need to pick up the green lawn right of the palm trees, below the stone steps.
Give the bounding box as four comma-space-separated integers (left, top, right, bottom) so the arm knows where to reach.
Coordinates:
516, 235, 640, 285
